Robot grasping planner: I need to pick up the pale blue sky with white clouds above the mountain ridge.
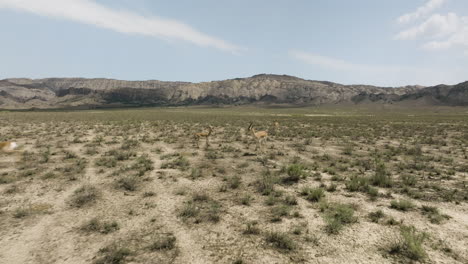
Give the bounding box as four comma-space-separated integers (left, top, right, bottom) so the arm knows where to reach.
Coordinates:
0, 0, 468, 86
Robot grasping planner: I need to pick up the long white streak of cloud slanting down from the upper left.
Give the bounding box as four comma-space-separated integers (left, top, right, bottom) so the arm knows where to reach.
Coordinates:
0, 0, 243, 53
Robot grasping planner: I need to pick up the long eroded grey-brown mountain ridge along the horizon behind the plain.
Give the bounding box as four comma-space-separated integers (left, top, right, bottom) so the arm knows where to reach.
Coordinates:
0, 74, 468, 109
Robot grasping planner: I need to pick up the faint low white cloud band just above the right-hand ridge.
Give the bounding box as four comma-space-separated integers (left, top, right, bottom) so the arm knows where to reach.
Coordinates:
289, 50, 466, 86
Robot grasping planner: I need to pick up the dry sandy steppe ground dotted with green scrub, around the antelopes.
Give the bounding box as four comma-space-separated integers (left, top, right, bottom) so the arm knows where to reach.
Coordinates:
0, 108, 468, 264
